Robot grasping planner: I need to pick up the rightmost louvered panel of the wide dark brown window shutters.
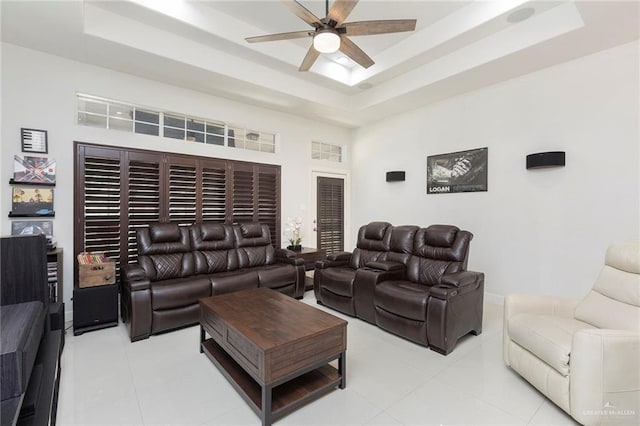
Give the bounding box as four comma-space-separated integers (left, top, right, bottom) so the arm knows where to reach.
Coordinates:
256, 166, 280, 244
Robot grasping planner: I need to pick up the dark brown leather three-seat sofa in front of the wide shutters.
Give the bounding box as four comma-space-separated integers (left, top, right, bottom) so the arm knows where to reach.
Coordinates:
121, 223, 304, 341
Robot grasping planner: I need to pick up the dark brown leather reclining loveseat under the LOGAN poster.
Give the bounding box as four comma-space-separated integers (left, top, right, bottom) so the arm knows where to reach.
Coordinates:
314, 222, 484, 355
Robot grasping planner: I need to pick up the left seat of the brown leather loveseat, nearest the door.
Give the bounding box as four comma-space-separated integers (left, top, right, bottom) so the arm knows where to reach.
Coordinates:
313, 222, 392, 316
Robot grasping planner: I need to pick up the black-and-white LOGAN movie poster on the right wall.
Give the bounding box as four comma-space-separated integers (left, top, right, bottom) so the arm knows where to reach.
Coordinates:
427, 148, 488, 194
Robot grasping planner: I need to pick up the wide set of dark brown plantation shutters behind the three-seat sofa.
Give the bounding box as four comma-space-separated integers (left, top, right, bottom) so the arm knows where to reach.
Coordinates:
74, 142, 280, 266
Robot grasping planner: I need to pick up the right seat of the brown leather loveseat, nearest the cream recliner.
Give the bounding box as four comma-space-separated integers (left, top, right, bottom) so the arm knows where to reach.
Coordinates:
374, 225, 484, 355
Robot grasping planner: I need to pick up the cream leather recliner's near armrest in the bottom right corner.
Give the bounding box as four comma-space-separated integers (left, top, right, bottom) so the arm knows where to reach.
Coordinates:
569, 329, 640, 424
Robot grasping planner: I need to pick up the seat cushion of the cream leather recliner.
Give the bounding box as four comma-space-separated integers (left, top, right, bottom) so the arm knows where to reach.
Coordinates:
507, 314, 594, 377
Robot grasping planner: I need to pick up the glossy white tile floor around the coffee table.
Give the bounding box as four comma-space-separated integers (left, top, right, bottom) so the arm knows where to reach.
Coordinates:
57, 291, 575, 425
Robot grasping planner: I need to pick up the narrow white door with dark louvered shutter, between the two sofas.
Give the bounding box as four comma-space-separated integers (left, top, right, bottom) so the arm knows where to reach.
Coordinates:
316, 176, 345, 254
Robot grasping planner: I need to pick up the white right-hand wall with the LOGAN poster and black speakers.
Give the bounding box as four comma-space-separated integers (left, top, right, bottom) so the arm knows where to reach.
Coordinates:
351, 42, 640, 297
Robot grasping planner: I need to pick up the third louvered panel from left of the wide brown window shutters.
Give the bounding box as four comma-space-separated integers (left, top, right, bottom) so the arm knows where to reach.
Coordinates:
167, 157, 196, 225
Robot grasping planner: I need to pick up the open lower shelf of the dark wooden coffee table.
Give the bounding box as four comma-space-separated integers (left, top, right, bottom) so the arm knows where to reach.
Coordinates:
201, 338, 344, 424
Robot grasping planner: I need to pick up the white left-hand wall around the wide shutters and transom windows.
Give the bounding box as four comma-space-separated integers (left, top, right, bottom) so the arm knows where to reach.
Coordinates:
0, 43, 351, 310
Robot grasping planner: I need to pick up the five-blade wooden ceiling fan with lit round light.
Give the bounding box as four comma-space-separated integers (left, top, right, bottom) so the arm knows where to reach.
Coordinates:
245, 0, 416, 71
